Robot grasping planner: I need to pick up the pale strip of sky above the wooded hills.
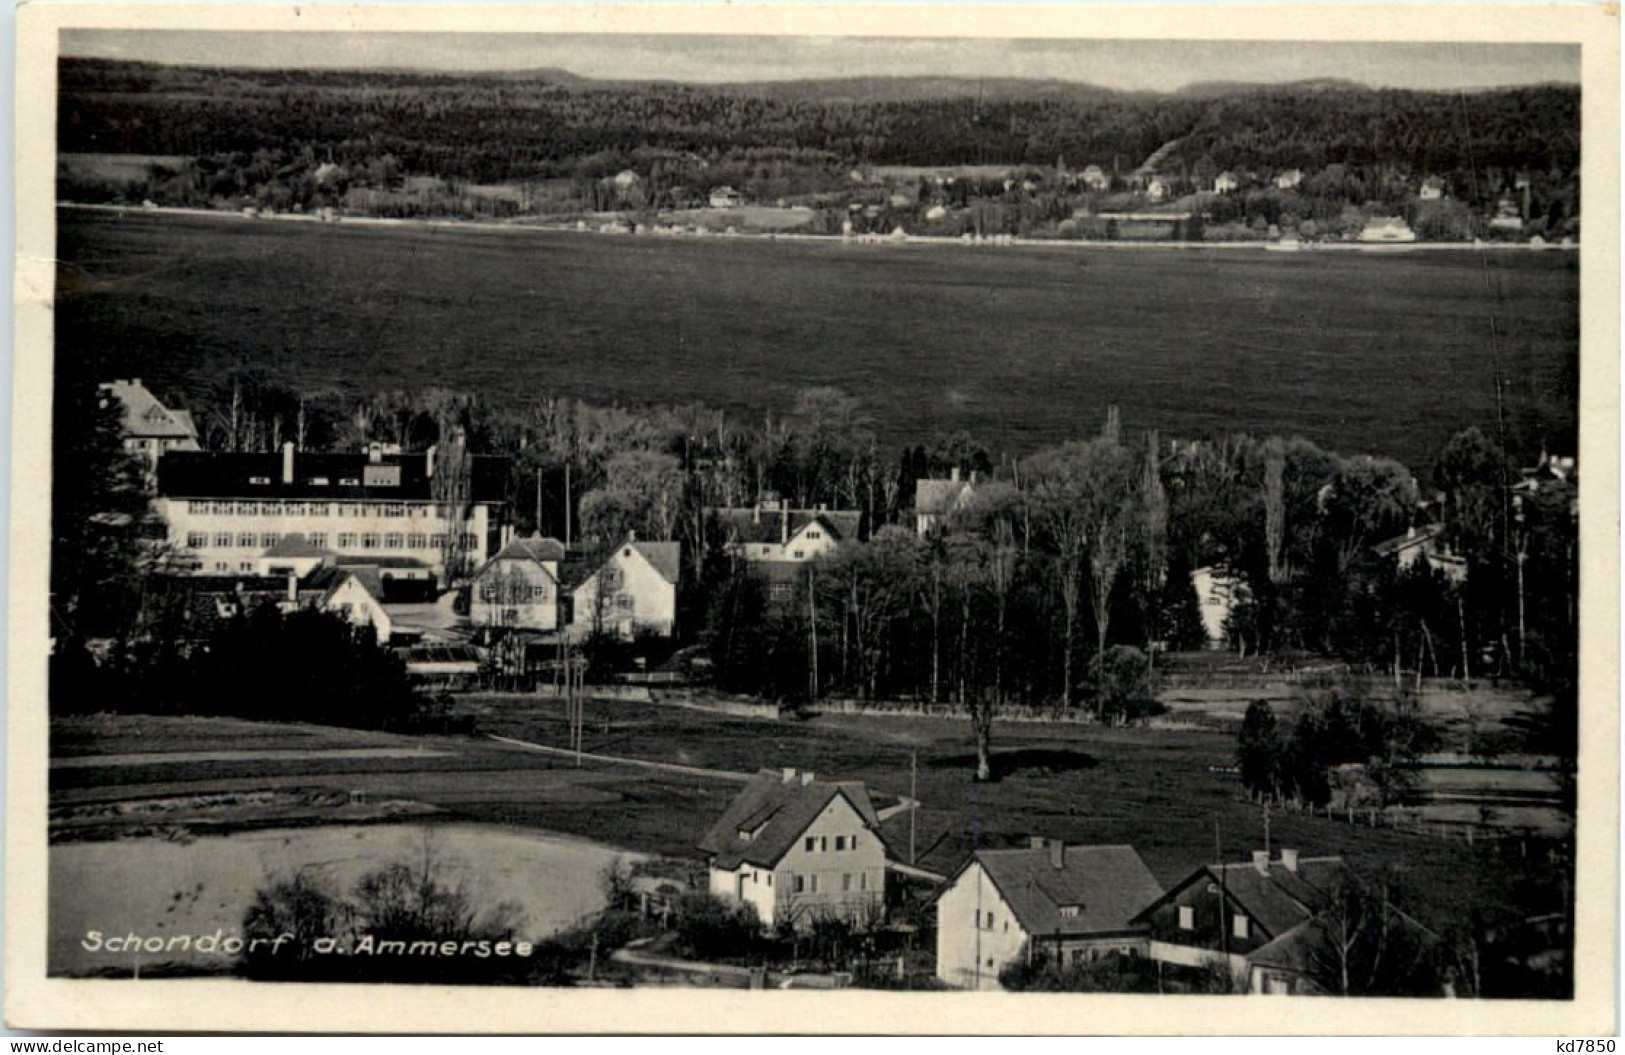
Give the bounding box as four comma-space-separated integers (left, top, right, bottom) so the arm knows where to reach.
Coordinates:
62, 29, 1580, 91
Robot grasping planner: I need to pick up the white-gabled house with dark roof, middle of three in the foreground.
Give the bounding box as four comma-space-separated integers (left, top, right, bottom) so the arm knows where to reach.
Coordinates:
936, 837, 1162, 990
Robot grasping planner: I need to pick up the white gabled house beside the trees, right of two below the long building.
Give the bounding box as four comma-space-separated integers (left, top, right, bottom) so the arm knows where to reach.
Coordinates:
566, 535, 683, 640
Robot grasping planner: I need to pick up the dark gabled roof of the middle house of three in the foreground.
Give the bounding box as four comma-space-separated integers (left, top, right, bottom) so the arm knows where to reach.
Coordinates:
949, 845, 1162, 936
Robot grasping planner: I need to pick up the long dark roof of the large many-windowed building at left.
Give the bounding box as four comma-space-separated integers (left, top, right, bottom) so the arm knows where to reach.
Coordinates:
158, 450, 509, 502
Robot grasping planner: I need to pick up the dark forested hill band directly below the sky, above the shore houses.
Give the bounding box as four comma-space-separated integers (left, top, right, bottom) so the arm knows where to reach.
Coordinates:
59, 59, 1580, 188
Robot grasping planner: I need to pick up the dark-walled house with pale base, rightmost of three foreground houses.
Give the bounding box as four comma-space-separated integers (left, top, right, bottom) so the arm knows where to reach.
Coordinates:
1134, 850, 1347, 993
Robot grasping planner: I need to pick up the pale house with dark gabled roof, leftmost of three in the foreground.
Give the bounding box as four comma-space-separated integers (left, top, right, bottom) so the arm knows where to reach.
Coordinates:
699, 769, 887, 927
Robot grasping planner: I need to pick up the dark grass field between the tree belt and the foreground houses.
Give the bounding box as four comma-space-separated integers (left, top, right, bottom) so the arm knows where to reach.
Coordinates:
50, 697, 1557, 949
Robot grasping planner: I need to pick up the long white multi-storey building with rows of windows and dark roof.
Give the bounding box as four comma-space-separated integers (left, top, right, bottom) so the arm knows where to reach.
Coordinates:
158, 444, 509, 582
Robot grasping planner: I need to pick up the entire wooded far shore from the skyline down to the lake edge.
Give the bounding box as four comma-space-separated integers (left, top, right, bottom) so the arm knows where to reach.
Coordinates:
59, 59, 1580, 239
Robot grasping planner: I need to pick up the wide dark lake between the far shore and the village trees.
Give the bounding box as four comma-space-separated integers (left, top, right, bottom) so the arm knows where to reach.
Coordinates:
55, 210, 1580, 471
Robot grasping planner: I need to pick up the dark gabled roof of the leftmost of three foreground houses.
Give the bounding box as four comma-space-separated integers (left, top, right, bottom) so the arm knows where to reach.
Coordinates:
699, 769, 884, 870
